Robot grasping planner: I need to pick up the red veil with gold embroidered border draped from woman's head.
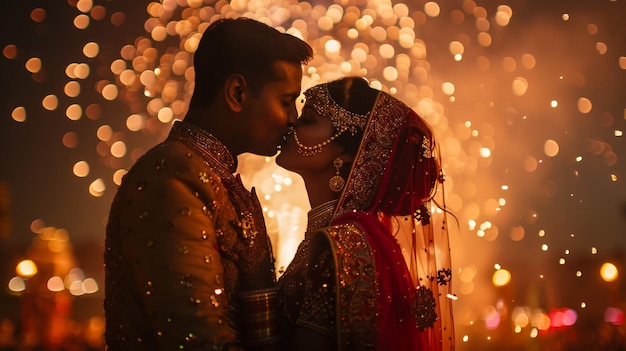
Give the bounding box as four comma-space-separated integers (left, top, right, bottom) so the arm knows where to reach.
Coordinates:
331, 92, 454, 350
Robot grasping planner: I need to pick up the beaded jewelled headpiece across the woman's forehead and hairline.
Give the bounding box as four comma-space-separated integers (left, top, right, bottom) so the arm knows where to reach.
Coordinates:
304, 84, 367, 135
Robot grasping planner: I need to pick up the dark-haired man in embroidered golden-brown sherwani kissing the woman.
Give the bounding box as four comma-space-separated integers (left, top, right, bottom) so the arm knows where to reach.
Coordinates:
104, 18, 312, 351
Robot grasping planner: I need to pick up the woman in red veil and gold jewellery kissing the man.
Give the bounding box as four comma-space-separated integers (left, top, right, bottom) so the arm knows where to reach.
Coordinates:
276, 77, 454, 350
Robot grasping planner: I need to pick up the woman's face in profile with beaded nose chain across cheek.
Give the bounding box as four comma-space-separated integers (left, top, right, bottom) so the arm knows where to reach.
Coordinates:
276, 104, 343, 174
